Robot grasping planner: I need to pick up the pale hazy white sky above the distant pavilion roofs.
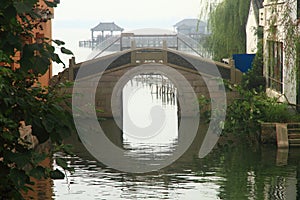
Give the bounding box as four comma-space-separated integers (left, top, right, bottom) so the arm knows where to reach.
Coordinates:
55, 0, 201, 29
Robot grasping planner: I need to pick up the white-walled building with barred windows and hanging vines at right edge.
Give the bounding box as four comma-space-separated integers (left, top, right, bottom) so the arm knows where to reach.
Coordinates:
259, 0, 300, 104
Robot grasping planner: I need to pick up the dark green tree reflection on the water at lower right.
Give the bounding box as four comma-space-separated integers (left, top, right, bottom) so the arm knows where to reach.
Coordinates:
198, 147, 299, 200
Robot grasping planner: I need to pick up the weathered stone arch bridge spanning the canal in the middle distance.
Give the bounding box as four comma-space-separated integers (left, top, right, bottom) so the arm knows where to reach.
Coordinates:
51, 48, 242, 117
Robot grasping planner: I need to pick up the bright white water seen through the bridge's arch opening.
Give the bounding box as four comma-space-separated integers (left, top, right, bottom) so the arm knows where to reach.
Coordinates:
122, 74, 178, 160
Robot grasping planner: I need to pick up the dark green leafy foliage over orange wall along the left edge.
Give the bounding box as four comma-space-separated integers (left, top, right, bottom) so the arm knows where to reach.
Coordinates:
0, 0, 73, 199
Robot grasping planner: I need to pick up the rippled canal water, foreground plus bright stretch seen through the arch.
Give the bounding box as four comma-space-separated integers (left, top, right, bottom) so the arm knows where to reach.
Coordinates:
52, 75, 300, 200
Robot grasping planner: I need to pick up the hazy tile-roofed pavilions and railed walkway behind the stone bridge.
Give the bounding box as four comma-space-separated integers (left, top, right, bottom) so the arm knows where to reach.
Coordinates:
79, 19, 211, 59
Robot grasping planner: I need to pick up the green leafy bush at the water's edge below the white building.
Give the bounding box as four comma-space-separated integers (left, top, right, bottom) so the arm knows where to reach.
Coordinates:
224, 86, 300, 135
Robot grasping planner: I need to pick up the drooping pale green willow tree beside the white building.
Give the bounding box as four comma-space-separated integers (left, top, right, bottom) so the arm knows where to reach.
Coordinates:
205, 0, 250, 60
